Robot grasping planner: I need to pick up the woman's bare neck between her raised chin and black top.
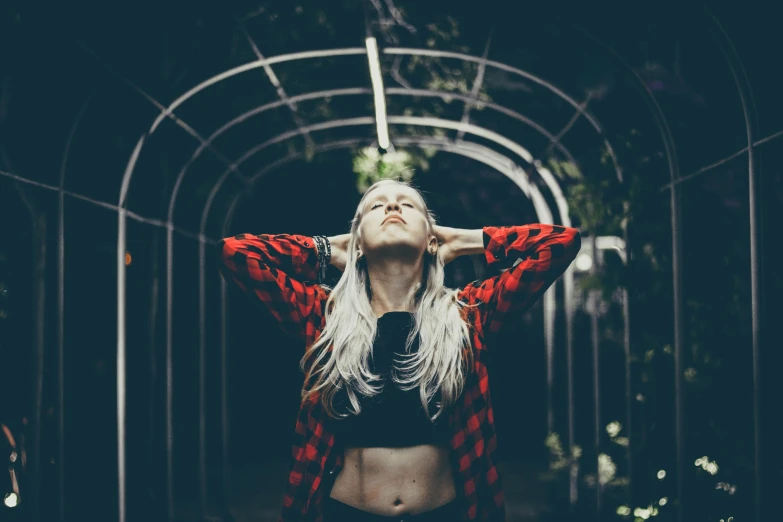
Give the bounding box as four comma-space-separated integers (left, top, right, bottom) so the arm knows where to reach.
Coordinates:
367, 254, 423, 317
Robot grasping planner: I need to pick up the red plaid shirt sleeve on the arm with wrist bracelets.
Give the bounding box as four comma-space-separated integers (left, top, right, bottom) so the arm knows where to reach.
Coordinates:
219, 234, 326, 339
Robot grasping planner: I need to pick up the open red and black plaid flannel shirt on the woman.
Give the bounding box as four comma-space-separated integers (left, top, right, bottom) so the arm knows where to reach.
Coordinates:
221, 224, 581, 522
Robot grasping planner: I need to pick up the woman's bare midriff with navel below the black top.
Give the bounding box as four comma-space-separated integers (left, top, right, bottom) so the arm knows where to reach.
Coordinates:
329, 444, 456, 516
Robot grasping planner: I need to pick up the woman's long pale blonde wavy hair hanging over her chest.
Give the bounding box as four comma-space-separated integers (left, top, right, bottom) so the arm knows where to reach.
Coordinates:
299, 179, 473, 422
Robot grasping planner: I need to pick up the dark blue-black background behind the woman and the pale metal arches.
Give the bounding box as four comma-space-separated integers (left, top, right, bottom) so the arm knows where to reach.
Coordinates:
0, 0, 783, 521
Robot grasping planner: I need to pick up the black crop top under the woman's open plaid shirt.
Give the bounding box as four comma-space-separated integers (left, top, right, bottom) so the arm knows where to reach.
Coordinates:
327, 311, 451, 448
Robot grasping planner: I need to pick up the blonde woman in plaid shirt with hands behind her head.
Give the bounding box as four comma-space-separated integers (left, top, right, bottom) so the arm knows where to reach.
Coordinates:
221, 180, 580, 522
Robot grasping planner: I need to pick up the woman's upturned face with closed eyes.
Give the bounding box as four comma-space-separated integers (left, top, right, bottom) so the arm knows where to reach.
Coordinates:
359, 183, 437, 261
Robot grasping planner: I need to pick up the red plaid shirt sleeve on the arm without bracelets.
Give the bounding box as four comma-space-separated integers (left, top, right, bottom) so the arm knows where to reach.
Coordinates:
460, 224, 581, 340
